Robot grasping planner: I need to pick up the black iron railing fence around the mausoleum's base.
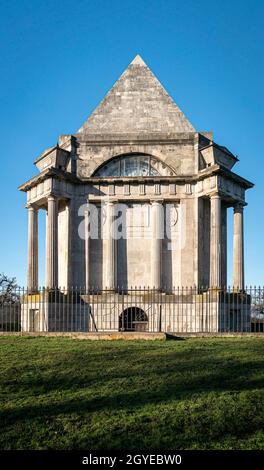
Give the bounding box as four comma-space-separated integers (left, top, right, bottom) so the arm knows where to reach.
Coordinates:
0, 286, 264, 333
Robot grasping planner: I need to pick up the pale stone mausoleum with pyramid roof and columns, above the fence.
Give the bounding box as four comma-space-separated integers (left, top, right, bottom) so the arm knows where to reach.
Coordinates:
20, 56, 253, 334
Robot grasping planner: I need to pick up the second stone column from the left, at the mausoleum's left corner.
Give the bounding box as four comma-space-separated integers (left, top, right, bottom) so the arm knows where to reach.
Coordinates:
46, 196, 58, 289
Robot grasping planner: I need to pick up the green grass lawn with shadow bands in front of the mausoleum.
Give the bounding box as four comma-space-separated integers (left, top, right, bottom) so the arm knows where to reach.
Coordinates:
0, 337, 264, 450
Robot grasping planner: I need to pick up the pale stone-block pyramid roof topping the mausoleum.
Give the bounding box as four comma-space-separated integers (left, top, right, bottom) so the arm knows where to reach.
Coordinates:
78, 55, 195, 135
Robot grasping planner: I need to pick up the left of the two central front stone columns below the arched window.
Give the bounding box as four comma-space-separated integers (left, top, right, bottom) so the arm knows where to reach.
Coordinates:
104, 201, 116, 290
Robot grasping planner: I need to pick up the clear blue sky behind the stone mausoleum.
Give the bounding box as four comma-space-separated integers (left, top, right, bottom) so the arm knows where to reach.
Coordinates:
0, 0, 264, 284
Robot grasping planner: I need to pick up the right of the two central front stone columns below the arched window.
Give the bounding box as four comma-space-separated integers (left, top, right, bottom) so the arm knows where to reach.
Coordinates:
150, 201, 164, 289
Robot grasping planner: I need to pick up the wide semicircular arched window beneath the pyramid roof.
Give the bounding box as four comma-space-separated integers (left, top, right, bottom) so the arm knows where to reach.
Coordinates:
93, 153, 174, 178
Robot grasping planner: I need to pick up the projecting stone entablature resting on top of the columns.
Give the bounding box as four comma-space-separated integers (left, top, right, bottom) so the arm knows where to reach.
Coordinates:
19, 160, 253, 204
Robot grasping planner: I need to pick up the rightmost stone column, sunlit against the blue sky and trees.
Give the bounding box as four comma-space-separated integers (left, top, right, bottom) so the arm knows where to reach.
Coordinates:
233, 204, 244, 290
